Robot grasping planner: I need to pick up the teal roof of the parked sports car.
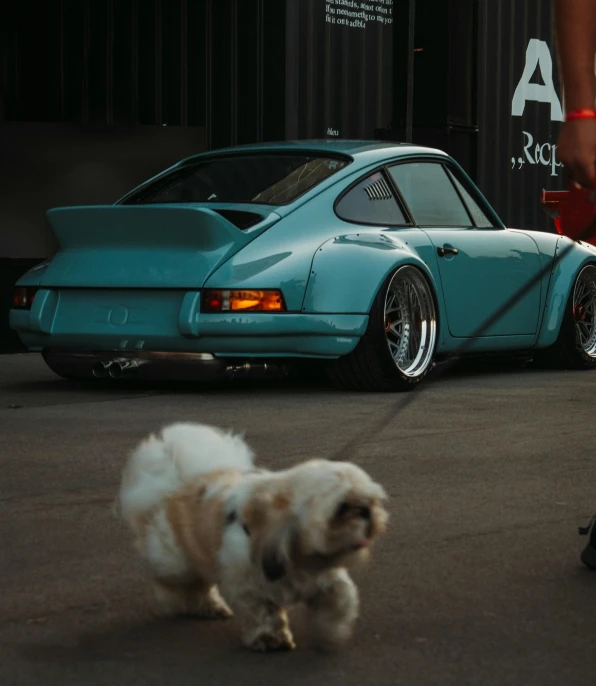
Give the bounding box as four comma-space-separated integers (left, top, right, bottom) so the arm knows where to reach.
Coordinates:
181, 138, 447, 164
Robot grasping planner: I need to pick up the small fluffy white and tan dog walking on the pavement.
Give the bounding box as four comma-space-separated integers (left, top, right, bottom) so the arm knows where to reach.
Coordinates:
119, 424, 387, 651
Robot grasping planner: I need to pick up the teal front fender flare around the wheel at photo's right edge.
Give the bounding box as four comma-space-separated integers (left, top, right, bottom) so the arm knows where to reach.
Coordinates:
536, 238, 596, 348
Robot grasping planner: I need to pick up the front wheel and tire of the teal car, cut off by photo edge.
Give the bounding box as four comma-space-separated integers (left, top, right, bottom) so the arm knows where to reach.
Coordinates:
535, 264, 596, 369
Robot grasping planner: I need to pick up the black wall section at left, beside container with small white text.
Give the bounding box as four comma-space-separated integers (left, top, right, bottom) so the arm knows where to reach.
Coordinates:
0, 0, 286, 258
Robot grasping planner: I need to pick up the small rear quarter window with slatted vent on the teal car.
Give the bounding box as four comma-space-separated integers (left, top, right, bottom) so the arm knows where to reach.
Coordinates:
335, 172, 408, 226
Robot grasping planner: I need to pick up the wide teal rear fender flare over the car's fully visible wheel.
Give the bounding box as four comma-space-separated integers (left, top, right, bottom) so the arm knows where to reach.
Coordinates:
302, 230, 443, 318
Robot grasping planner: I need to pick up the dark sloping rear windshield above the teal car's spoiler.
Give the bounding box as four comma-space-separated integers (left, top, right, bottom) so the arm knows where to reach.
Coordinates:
123, 154, 349, 205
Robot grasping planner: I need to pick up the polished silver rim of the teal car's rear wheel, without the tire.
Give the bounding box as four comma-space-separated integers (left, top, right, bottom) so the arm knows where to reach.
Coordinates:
384, 266, 437, 378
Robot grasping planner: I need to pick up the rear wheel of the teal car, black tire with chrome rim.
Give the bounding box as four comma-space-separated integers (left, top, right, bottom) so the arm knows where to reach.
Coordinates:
327, 265, 437, 393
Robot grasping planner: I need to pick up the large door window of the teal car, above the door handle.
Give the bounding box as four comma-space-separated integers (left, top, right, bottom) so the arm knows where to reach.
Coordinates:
389, 162, 473, 226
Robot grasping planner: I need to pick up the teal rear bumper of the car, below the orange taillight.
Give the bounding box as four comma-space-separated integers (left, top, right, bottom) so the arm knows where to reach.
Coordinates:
10, 302, 368, 361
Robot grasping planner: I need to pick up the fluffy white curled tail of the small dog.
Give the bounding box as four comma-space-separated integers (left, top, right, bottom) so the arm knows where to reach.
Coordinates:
116, 424, 253, 521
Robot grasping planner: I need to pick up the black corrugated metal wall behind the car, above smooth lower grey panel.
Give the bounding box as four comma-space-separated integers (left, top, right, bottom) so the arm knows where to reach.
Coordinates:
0, 0, 563, 234
